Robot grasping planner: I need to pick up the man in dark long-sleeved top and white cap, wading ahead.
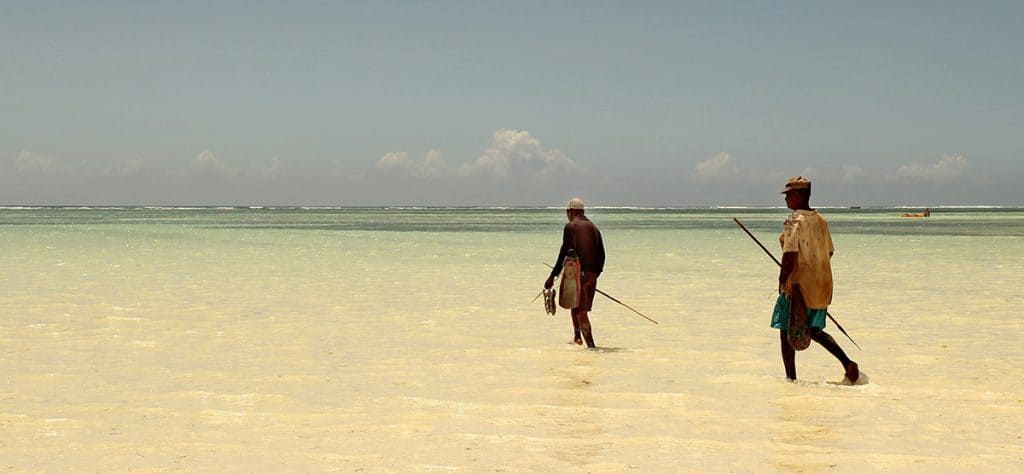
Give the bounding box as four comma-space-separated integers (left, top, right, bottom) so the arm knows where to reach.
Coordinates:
544, 198, 604, 347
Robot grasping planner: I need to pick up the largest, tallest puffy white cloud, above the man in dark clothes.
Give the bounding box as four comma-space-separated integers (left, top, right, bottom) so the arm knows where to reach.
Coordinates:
459, 129, 580, 178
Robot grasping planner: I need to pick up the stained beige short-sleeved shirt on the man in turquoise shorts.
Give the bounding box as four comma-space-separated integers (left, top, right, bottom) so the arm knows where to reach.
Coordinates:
778, 211, 836, 309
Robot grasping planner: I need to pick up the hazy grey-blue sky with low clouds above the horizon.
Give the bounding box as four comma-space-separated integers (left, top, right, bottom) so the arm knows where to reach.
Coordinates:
0, 0, 1024, 206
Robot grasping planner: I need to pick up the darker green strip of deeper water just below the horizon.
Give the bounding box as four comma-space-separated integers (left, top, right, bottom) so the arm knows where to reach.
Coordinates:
8, 208, 1024, 236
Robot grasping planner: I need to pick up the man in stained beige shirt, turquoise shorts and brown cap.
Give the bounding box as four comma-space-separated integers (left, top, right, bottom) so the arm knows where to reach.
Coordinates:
771, 176, 860, 383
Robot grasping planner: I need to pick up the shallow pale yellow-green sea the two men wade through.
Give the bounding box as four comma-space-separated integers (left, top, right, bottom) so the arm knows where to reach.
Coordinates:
0, 207, 1024, 472
